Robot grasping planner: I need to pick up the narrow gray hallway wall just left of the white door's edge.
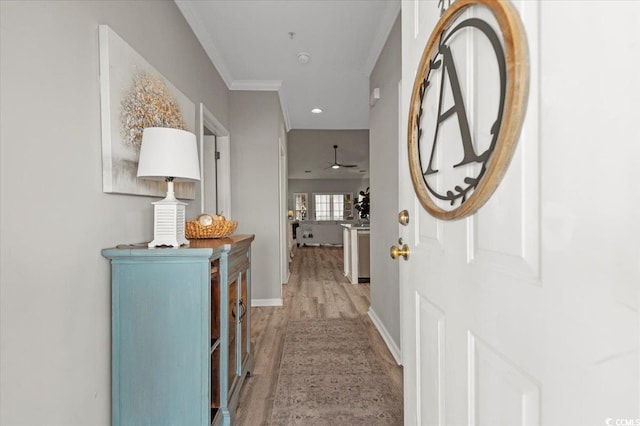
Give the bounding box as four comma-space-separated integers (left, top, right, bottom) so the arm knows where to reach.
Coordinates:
369, 17, 405, 348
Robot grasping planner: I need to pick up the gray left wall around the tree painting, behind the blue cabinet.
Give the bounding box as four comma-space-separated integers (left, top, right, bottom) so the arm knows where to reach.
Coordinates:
0, 0, 229, 425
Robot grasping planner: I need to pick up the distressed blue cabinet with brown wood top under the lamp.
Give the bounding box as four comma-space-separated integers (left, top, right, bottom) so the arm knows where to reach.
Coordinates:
102, 235, 253, 426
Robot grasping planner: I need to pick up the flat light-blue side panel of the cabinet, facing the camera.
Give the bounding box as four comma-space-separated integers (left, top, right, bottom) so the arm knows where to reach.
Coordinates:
112, 262, 210, 425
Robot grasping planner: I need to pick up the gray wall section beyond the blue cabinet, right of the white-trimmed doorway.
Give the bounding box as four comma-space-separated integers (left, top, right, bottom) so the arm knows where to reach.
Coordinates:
229, 91, 286, 303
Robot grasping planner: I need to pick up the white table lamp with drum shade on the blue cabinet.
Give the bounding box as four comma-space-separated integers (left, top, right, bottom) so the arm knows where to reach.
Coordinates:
138, 127, 200, 247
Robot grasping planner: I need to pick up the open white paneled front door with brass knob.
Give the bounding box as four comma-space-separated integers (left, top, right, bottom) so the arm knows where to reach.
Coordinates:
399, 0, 640, 425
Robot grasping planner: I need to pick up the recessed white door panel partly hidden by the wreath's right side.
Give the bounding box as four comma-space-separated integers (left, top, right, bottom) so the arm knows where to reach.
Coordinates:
467, 0, 542, 286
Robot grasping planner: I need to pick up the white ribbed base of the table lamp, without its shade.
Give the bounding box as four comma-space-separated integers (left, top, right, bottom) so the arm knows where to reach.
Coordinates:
149, 182, 189, 247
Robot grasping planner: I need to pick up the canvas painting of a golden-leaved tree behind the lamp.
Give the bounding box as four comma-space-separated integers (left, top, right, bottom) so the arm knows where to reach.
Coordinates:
99, 25, 195, 199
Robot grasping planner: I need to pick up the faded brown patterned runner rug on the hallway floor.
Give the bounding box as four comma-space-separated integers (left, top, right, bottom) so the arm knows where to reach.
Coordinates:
271, 319, 402, 426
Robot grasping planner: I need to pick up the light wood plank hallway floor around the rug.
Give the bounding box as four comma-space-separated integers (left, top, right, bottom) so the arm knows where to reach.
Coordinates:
236, 247, 402, 426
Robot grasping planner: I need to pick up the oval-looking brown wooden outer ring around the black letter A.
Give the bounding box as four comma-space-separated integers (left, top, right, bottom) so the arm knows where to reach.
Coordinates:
408, 0, 529, 220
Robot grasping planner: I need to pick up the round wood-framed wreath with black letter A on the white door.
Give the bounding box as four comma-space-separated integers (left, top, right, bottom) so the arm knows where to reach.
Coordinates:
408, 0, 529, 220
